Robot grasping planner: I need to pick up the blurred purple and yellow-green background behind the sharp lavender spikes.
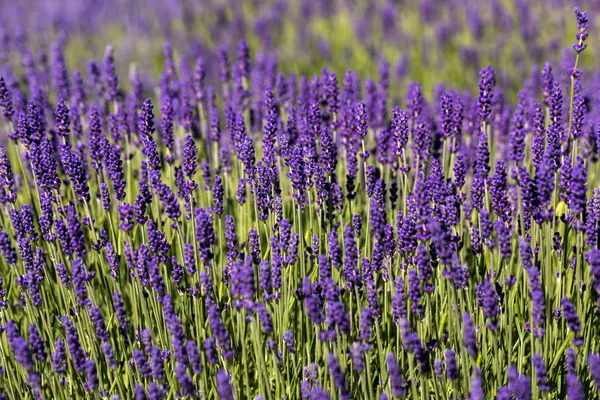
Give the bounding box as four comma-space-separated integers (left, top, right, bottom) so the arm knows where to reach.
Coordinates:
0, 0, 600, 101
